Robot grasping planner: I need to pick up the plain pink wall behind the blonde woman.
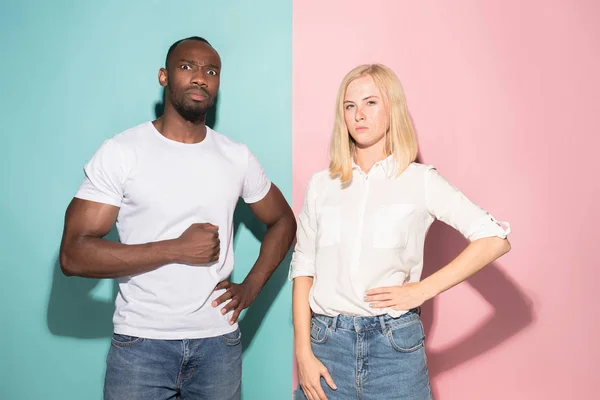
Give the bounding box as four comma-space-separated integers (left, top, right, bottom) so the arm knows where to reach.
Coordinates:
293, 0, 600, 400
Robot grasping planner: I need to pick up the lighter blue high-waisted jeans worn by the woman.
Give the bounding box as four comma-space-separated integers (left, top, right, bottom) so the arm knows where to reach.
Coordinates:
294, 310, 432, 400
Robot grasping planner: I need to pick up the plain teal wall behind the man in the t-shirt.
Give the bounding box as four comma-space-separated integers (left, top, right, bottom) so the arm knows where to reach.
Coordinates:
0, 0, 292, 400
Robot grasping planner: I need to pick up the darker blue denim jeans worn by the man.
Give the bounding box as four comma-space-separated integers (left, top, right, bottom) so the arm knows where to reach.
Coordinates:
104, 329, 242, 400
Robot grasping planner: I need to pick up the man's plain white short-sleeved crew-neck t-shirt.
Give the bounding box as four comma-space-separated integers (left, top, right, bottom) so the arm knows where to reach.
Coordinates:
75, 122, 271, 339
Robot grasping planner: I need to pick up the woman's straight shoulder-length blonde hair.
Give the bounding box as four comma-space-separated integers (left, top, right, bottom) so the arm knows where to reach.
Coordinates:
329, 64, 418, 186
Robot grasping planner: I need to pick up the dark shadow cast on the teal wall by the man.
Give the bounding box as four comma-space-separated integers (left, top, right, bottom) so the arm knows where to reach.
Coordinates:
47, 94, 291, 349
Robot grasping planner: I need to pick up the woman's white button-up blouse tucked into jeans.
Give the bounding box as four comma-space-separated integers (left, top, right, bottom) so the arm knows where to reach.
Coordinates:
290, 156, 510, 317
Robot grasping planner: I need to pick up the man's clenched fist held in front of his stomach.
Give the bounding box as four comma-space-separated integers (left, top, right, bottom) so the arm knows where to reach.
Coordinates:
176, 223, 221, 265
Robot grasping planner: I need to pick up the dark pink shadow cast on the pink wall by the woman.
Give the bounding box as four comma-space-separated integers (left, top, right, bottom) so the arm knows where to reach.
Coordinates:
421, 221, 535, 399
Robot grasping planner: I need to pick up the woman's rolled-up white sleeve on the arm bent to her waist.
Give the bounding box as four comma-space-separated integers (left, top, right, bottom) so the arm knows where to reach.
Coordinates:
425, 167, 511, 241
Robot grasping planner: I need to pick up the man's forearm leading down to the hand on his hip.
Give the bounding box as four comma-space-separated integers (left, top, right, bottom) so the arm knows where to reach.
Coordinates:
244, 214, 296, 294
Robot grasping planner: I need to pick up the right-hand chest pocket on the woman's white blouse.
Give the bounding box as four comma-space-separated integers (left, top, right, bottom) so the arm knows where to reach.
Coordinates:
373, 204, 416, 249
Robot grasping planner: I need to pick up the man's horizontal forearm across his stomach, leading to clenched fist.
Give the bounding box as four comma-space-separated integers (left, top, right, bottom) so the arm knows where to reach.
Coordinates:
60, 237, 175, 278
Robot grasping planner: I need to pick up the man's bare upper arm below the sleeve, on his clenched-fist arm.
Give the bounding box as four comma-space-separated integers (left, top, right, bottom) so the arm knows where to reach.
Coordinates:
65, 198, 119, 239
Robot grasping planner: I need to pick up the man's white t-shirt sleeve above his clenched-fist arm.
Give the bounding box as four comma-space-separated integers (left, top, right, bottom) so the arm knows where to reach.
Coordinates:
75, 139, 125, 207
